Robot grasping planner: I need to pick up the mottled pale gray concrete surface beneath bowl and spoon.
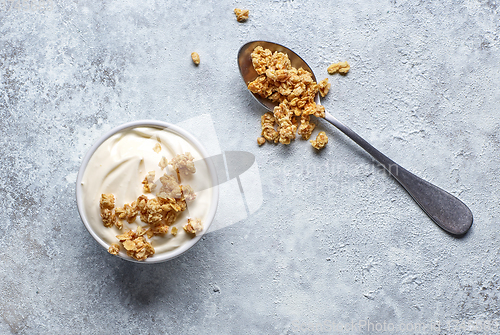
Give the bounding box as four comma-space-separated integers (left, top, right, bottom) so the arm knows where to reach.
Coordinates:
0, 0, 500, 334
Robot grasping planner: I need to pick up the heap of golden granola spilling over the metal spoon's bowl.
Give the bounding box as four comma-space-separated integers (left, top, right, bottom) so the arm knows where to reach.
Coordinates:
248, 46, 330, 145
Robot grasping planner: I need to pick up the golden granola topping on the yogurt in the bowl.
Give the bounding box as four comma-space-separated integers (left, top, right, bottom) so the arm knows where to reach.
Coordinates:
99, 153, 203, 261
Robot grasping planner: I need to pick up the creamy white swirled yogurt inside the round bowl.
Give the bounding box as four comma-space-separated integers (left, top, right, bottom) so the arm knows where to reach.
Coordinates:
81, 127, 213, 257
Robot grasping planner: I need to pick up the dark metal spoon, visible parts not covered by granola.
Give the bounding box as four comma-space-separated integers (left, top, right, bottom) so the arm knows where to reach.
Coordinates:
238, 41, 473, 235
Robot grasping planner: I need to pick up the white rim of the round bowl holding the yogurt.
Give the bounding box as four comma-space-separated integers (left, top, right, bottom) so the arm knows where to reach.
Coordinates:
76, 120, 219, 264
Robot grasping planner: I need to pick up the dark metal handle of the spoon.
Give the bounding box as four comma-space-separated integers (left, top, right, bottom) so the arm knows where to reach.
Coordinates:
325, 113, 473, 235
